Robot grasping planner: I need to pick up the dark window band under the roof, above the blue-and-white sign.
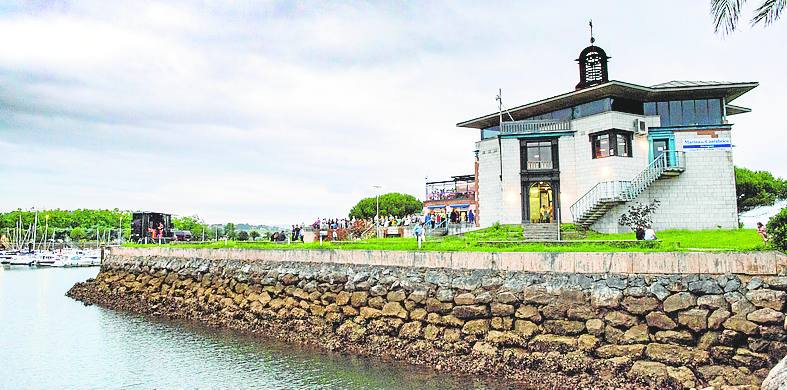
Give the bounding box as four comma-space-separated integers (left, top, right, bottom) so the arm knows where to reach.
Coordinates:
643, 99, 722, 127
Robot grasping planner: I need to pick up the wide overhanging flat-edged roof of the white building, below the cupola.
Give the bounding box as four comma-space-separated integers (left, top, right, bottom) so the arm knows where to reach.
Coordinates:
456, 80, 759, 129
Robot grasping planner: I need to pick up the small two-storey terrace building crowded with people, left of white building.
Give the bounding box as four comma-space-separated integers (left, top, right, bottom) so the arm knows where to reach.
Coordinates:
424, 175, 478, 222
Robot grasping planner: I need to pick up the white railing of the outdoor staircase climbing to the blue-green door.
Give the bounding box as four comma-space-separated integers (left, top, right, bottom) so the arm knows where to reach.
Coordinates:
570, 150, 686, 222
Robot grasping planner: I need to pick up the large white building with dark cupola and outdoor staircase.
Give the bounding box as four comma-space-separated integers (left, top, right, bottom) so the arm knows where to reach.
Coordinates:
457, 40, 758, 236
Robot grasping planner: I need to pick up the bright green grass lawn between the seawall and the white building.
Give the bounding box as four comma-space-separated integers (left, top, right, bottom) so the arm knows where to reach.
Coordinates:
126, 225, 769, 252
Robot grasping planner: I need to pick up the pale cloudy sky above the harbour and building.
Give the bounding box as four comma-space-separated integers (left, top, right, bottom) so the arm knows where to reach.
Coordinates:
0, 0, 787, 225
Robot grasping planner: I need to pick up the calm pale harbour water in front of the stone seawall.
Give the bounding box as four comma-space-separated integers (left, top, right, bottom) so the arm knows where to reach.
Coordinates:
0, 268, 499, 389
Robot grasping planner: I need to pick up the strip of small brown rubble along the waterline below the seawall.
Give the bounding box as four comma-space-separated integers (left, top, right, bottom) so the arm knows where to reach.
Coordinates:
66, 271, 681, 390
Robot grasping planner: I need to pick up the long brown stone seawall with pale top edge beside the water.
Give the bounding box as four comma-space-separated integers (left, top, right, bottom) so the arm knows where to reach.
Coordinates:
68, 248, 787, 388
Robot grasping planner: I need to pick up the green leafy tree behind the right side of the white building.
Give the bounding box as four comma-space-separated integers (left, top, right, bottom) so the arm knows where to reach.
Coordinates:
735, 167, 787, 213
